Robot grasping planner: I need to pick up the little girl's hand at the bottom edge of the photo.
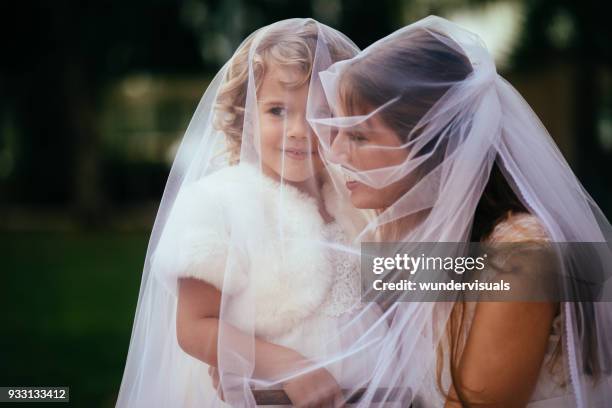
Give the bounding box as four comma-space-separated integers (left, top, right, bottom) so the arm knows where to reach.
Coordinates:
283, 368, 345, 408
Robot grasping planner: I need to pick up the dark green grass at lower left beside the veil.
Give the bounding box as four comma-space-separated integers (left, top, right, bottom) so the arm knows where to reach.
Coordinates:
0, 232, 148, 407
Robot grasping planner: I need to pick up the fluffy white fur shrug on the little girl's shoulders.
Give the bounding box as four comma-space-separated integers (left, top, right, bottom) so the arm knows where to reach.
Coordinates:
152, 165, 364, 338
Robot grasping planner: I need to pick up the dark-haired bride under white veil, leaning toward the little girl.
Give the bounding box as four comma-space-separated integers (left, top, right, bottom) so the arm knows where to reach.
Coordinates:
309, 17, 612, 408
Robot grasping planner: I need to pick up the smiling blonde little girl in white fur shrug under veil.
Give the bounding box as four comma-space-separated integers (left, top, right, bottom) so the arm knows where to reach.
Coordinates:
118, 20, 386, 407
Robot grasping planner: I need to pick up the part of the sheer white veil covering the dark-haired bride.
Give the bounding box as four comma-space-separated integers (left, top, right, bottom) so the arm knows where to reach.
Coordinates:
309, 17, 612, 407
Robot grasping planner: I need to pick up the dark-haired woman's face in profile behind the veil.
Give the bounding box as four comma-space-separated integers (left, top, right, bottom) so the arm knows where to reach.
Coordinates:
330, 113, 408, 209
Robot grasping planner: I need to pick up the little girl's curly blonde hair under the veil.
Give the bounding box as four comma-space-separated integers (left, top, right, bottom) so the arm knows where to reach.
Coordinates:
213, 20, 355, 164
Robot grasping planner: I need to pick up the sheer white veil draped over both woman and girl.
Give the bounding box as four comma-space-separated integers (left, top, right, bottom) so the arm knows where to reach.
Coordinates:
117, 17, 612, 407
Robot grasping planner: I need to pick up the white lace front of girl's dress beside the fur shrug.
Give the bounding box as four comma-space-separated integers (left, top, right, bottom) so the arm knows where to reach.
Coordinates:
321, 222, 361, 317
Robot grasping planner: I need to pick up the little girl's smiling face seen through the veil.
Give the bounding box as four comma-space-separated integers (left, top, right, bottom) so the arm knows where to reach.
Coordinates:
257, 64, 323, 182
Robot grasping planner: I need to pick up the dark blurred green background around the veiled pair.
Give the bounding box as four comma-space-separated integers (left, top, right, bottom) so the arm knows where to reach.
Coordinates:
0, 0, 612, 407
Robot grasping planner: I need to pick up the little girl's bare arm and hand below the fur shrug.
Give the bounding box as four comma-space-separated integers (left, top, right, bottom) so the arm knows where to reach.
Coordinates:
176, 278, 343, 406
